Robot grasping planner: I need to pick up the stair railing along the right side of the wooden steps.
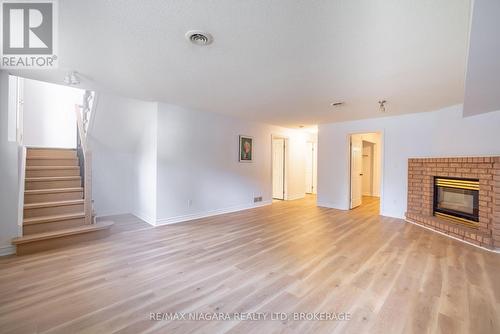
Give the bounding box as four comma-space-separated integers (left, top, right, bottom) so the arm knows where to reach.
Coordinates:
75, 105, 92, 224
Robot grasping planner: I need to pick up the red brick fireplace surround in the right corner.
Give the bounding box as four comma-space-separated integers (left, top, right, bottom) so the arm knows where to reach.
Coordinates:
406, 157, 500, 249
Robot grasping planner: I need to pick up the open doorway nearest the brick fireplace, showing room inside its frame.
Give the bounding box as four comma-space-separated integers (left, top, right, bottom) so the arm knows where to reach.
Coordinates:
349, 132, 381, 209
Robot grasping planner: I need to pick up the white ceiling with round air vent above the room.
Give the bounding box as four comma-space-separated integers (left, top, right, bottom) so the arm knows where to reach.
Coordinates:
11, 0, 470, 126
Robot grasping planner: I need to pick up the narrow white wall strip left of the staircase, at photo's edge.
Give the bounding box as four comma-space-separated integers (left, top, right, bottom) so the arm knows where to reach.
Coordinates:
0, 71, 18, 255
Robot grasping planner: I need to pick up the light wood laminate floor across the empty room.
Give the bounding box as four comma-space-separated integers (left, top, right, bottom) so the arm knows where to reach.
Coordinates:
0, 196, 500, 334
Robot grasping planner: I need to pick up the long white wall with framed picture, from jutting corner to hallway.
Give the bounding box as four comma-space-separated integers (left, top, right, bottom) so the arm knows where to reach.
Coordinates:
157, 104, 306, 224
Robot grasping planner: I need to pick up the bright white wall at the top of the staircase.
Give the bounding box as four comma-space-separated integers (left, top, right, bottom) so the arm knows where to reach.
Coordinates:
23, 79, 85, 148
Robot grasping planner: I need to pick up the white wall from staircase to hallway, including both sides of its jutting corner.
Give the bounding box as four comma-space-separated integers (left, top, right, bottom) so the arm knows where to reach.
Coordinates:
89, 95, 310, 224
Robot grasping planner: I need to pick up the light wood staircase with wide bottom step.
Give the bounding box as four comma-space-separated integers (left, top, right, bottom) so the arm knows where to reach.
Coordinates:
12, 148, 113, 255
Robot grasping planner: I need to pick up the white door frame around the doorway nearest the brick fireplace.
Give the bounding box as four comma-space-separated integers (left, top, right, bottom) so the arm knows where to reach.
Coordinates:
346, 129, 385, 215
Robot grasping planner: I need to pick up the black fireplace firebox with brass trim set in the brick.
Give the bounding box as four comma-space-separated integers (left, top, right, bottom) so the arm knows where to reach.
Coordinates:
434, 176, 479, 227
